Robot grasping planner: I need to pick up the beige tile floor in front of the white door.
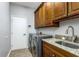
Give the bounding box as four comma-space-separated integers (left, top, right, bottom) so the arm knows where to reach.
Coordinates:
9, 49, 32, 57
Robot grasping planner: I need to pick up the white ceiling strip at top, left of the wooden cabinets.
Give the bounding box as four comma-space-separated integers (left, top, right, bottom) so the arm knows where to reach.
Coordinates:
12, 2, 41, 9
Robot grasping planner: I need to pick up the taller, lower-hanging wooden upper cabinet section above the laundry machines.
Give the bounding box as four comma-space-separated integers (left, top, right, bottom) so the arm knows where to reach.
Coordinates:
35, 2, 59, 28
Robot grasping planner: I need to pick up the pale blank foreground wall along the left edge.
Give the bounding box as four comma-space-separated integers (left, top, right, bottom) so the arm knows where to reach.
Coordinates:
0, 2, 11, 57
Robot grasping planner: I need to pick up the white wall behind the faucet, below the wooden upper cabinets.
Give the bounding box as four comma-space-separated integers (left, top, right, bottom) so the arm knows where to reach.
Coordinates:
37, 18, 79, 37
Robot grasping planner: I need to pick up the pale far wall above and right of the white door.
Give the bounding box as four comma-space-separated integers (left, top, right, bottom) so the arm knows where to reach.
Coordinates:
11, 3, 35, 49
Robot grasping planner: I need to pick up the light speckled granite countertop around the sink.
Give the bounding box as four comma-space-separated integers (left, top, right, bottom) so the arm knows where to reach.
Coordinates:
42, 38, 79, 56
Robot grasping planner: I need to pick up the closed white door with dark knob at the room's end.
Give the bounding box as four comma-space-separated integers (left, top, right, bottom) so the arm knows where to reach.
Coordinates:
11, 17, 28, 50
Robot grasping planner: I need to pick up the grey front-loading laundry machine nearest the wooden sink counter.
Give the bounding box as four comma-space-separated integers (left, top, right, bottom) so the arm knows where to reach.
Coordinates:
32, 34, 52, 57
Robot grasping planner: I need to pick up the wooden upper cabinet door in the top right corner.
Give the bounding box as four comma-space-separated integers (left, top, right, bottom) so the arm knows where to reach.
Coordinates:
68, 2, 79, 15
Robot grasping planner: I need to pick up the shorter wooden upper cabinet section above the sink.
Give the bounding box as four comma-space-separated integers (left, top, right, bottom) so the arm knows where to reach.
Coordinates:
54, 2, 79, 22
